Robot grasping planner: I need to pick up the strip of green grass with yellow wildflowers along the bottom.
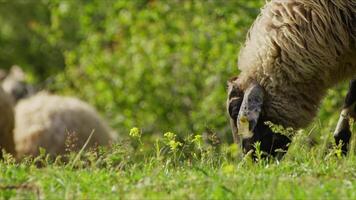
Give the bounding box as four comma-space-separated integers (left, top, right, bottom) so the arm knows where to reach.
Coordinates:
0, 124, 356, 199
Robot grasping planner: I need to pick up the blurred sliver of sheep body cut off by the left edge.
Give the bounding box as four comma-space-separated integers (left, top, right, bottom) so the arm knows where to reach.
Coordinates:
0, 87, 15, 157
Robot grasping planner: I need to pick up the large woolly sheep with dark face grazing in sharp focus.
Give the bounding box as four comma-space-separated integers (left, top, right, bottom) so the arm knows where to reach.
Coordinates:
227, 0, 356, 155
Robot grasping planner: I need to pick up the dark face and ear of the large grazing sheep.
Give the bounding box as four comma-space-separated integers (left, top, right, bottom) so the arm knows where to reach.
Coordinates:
227, 77, 290, 156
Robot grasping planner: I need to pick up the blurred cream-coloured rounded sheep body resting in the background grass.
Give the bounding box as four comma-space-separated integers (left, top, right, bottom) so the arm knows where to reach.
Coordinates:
14, 92, 115, 158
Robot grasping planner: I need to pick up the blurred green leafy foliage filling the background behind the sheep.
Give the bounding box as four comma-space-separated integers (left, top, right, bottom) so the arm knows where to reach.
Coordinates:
0, 0, 348, 140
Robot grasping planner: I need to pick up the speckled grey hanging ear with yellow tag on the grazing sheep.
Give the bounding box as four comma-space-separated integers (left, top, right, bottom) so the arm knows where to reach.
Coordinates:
237, 83, 264, 134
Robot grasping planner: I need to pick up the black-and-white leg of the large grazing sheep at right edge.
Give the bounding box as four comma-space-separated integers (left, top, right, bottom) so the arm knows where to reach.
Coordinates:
334, 79, 356, 154
